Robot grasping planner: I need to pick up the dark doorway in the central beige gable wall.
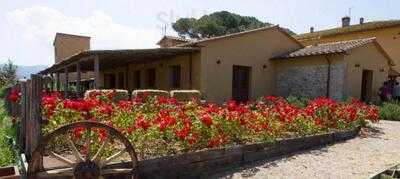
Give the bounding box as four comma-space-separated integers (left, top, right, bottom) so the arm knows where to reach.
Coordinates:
232, 65, 251, 102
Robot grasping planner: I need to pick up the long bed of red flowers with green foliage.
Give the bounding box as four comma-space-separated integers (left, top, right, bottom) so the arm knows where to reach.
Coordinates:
42, 93, 378, 158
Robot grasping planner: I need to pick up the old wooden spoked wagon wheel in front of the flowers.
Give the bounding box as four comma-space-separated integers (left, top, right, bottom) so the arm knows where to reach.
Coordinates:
28, 121, 138, 178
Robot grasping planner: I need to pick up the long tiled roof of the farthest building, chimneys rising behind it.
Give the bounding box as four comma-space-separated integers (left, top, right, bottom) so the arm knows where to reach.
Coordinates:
294, 20, 400, 41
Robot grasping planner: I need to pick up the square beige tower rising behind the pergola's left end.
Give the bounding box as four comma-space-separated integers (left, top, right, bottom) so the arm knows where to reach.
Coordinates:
53, 33, 90, 63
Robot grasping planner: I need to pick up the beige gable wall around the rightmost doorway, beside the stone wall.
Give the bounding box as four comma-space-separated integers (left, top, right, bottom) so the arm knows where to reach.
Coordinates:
345, 43, 389, 101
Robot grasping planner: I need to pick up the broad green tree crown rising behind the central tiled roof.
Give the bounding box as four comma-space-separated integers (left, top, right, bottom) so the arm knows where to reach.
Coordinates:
172, 11, 295, 38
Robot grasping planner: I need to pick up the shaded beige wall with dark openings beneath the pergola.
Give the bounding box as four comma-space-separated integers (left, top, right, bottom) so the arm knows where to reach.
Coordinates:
103, 53, 201, 90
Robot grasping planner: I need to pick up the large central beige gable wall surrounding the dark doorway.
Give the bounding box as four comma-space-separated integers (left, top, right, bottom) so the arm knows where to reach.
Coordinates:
199, 28, 300, 102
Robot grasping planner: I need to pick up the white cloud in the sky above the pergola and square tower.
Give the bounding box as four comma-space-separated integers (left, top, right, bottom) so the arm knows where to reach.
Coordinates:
6, 6, 160, 65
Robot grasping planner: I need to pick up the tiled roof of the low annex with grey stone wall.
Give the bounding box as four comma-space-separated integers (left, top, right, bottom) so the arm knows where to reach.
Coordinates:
275, 38, 375, 58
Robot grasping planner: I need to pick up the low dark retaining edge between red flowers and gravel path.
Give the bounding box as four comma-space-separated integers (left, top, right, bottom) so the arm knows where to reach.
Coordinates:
108, 128, 360, 179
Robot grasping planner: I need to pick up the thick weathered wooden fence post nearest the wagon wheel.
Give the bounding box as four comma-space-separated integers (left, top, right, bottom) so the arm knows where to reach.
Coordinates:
27, 74, 43, 159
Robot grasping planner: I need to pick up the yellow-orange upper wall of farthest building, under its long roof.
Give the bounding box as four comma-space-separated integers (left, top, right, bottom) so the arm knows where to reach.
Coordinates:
300, 26, 400, 71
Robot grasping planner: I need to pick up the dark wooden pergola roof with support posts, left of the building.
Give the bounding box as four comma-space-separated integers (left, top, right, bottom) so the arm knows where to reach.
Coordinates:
39, 47, 200, 95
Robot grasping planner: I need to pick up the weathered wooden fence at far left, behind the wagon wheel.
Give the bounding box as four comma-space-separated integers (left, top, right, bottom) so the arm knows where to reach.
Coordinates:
4, 74, 44, 160
